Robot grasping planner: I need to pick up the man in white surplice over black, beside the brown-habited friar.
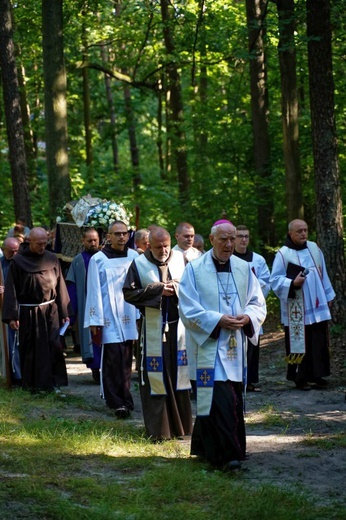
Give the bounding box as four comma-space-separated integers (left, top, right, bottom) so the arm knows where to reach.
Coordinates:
84, 221, 139, 419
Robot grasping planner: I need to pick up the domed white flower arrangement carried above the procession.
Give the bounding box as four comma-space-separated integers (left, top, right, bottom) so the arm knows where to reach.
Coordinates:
84, 200, 132, 230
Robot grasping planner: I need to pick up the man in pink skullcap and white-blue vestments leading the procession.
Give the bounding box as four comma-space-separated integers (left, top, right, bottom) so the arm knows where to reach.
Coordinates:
179, 220, 266, 471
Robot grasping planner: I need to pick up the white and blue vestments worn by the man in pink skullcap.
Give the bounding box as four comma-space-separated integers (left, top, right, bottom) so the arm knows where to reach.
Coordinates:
179, 251, 266, 415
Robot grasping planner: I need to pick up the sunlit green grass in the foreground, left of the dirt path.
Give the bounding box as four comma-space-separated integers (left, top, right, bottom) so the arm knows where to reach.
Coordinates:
0, 389, 346, 520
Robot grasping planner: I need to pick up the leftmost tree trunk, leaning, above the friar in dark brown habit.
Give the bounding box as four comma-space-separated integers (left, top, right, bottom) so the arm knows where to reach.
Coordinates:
0, 0, 32, 227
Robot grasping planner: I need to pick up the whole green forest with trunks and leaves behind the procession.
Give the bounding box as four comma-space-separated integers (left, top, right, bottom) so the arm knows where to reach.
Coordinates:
0, 0, 346, 322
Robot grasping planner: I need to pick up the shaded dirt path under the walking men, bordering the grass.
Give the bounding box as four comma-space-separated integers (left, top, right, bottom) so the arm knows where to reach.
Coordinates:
64, 332, 346, 505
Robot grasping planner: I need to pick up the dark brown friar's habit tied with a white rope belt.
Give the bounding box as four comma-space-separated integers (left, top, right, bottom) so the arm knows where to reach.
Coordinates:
2, 246, 71, 391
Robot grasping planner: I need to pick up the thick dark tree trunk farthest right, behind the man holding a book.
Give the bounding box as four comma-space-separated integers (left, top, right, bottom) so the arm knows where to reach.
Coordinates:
306, 0, 346, 324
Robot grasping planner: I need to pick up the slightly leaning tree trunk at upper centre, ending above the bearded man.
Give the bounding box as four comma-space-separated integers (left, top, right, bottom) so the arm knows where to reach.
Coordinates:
160, 0, 189, 204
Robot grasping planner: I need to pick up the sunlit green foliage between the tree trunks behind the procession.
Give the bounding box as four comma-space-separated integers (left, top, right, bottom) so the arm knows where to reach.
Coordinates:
0, 0, 346, 253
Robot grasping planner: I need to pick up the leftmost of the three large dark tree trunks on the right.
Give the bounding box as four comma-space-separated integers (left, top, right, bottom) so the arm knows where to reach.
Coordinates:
246, 0, 276, 249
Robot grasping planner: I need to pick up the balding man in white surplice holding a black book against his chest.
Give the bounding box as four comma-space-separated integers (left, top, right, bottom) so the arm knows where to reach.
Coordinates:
270, 219, 335, 390
